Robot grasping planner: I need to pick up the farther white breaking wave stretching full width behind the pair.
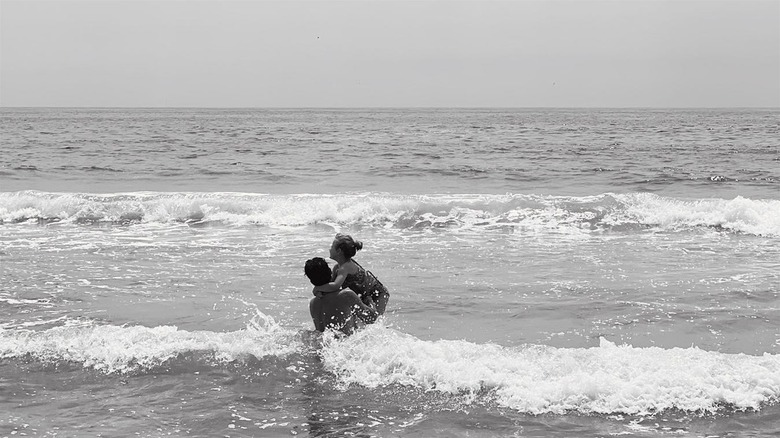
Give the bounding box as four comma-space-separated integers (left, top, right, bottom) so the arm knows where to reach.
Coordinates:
0, 191, 780, 236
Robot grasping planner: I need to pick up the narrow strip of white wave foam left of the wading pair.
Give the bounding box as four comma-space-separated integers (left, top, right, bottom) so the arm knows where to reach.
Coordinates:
0, 314, 301, 373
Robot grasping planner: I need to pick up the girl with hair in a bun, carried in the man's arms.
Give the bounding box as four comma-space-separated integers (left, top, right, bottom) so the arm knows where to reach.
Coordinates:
314, 234, 390, 315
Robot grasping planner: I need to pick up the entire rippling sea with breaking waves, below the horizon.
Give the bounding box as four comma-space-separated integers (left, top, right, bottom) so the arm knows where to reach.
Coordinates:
0, 108, 780, 437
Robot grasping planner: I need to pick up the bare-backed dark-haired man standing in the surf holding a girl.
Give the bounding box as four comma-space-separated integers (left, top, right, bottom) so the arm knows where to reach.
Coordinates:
304, 257, 378, 335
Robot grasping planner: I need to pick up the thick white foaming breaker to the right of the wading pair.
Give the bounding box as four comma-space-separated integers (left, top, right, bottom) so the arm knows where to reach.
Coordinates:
323, 327, 780, 415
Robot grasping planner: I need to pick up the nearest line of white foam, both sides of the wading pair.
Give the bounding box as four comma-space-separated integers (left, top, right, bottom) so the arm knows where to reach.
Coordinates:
0, 321, 780, 415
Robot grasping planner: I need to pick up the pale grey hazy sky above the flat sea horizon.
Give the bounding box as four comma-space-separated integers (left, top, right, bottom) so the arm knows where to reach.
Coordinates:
0, 0, 780, 107
